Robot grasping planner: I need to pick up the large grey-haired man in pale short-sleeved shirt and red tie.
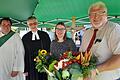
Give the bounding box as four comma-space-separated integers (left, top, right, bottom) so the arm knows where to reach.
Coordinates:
80, 2, 120, 80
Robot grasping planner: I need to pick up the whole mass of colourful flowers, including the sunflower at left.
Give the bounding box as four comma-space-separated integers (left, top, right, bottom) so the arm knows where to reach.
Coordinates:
34, 50, 96, 80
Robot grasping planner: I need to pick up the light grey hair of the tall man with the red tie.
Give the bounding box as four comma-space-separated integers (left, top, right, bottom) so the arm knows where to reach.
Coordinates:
88, 1, 107, 13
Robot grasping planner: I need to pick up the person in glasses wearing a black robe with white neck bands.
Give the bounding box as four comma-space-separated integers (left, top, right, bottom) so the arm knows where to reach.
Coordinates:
22, 16, 51, 80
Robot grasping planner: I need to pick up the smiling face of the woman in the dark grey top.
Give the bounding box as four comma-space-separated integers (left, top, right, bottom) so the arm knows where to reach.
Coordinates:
55, 25, 66, 39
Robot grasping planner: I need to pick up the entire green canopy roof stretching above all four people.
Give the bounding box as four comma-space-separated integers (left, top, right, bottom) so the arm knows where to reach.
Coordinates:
0, 0, 120, 27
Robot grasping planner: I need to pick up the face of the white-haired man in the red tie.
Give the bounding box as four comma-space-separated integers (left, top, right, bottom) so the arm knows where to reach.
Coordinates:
89, 6, 107, 28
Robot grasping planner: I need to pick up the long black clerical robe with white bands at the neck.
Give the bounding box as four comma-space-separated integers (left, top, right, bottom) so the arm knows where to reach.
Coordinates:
22, 30, 51, 80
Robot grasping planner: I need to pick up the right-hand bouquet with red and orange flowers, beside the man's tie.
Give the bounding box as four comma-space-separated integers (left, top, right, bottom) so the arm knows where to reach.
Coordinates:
55, 51, 97, 80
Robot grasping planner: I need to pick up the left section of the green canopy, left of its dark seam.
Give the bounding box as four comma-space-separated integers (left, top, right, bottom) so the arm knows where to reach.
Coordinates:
0, 0, 38, 27
